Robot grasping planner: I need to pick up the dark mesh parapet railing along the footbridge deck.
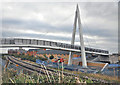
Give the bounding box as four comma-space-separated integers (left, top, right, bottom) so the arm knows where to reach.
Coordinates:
0, 38, 109, 54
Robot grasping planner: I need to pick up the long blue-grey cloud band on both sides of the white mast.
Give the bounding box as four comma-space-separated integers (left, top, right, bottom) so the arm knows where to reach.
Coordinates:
2, 19, 116, 37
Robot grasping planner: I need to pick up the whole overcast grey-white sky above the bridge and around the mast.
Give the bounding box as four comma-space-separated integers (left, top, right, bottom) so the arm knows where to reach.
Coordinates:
1, 2, 118, 53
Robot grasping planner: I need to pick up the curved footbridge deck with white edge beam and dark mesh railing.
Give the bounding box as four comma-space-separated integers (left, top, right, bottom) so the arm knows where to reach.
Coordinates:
0, 38, 109, 56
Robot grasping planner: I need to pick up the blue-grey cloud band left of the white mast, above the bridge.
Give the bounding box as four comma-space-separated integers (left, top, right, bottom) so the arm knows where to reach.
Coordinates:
2, 19, 72, 32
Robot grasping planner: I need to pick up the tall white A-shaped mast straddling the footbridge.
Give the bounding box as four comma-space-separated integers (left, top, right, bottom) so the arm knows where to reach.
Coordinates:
68, 5, 87, 68
